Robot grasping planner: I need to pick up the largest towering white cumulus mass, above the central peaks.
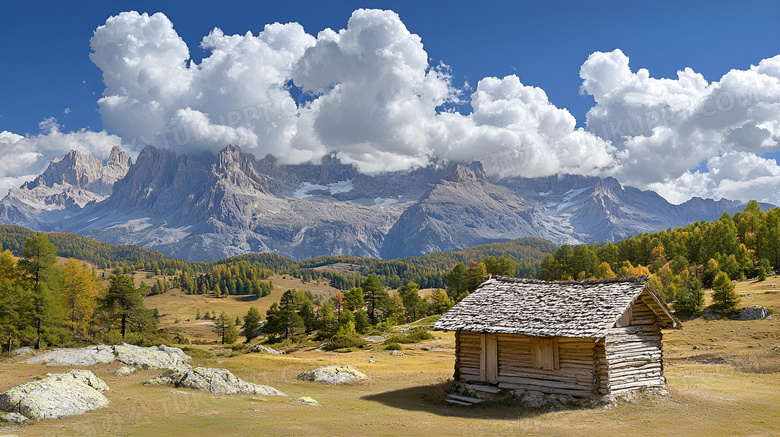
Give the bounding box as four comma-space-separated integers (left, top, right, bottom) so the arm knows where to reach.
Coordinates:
91, 9, 613, 176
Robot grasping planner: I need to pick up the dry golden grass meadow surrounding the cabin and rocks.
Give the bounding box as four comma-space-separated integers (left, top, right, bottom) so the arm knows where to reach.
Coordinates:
0, 277, 780, 436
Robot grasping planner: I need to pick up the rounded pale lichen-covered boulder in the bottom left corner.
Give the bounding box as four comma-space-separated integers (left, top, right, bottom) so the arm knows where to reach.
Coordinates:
0, 370, 109, 420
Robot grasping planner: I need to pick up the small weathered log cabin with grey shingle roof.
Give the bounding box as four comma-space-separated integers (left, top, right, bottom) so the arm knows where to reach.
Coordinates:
433, 276, 681, 398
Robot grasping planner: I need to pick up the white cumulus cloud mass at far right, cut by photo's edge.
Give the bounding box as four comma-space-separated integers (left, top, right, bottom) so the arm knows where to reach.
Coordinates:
580, 50, 780, 203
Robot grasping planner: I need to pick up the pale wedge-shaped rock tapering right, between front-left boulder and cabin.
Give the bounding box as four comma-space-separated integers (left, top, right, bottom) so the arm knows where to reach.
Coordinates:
145, 367, 287, 396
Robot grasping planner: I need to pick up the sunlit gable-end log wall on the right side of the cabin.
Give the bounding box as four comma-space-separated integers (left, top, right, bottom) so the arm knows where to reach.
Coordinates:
605, 300, 666, 394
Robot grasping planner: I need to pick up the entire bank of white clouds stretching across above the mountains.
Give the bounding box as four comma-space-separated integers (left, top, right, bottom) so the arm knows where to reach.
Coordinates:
0, 9, 780, 204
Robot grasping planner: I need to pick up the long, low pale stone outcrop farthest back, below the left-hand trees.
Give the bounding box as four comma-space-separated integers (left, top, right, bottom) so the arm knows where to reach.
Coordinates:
25, 343, 191, 370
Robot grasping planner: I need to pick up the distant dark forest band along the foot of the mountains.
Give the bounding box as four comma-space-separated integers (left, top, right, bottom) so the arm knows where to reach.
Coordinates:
0, 225, 558, 294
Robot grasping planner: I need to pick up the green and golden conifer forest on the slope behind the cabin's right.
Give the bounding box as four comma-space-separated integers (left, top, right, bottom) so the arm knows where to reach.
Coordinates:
540, 201, 780, 311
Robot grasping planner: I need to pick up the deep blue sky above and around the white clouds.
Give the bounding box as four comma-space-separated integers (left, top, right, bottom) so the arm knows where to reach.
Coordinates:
0, 1, 780, 204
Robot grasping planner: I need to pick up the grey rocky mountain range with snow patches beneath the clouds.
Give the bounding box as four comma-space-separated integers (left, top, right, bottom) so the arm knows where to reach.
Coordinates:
0, 146, 768, 261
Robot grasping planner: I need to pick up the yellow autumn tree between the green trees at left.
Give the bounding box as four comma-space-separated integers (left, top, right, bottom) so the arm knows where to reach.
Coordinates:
60, 258, 102, 339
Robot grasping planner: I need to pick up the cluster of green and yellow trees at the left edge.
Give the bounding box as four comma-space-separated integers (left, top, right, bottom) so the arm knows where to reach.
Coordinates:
0, 233, 164, 352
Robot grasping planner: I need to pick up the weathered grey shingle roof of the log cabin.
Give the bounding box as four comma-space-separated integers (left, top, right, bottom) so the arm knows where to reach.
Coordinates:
433, 276, 679, 338
